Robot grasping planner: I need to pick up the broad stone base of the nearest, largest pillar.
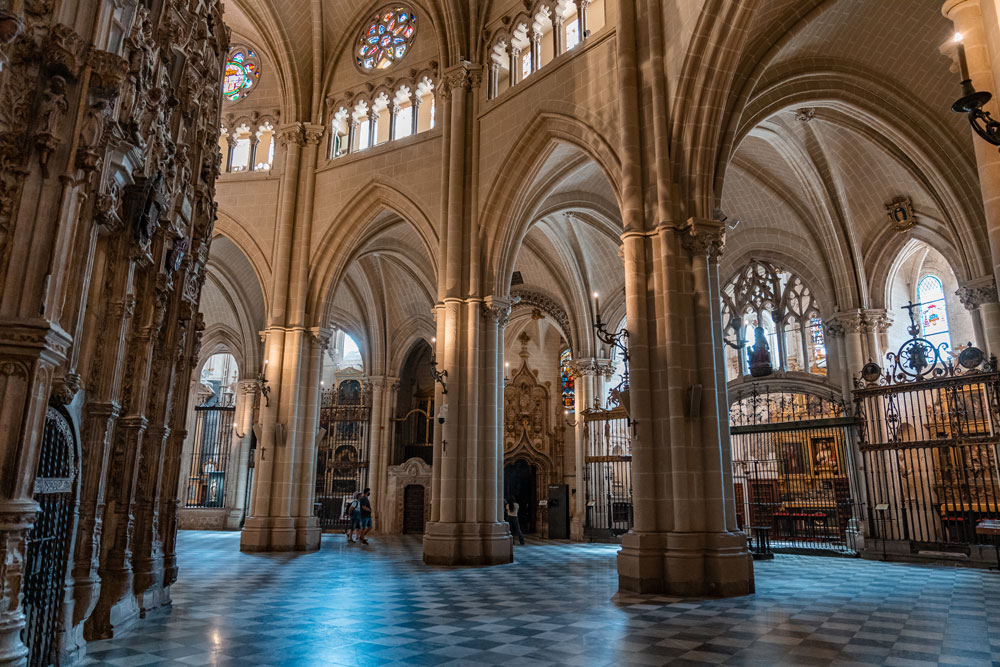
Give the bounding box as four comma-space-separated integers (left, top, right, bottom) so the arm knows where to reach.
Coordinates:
618, 532, 754, 597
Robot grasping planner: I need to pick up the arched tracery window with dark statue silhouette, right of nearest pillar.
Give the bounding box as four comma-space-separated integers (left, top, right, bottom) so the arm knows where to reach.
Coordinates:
722, 260, 826, 380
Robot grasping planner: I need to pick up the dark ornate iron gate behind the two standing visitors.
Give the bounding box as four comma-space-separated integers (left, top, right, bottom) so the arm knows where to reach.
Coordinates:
316, 380, 372, 529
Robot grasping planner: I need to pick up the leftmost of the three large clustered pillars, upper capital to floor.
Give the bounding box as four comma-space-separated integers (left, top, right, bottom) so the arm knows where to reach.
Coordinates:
240, 123, 332, 551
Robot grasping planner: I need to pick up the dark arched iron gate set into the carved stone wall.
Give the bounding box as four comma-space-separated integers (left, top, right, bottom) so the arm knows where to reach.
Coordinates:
22, 407, 77, 667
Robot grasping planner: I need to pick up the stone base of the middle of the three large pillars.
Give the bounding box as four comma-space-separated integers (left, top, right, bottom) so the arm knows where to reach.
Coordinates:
424, 522, 514, 565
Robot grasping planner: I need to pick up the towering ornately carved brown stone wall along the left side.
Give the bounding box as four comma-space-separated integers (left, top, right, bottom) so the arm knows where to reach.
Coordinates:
0, 0, 228, 664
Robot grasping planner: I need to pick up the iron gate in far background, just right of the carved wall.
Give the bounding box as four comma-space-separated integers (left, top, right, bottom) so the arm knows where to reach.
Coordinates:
184, 394, 236, 507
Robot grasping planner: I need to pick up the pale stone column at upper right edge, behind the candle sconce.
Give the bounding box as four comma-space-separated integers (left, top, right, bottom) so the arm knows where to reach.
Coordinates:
941, 0, 1000, 306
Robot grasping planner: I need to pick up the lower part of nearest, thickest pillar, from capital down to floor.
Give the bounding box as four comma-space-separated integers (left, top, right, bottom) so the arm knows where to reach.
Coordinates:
618, 219, 753, 596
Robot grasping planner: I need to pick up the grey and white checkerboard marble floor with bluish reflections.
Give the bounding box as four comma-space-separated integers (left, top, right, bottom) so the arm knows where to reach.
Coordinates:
84, 532, 1000, 667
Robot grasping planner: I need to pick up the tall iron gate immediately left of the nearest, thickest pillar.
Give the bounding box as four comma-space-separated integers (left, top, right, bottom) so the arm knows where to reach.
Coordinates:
583, 407, 633, 540
